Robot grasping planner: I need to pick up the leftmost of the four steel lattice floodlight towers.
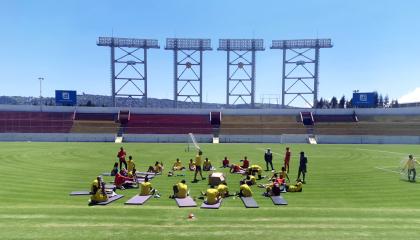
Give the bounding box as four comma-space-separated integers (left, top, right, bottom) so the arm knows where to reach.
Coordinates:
96, 37, 160, 107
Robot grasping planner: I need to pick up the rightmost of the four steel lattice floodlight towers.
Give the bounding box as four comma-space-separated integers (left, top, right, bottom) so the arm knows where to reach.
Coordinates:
271, 39, 333, 108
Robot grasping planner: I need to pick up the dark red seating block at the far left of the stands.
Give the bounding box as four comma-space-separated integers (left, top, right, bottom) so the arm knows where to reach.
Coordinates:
0, 111, 73, 133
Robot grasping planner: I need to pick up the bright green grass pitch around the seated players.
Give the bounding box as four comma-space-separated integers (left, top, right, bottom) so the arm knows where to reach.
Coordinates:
0, 142, 420, 240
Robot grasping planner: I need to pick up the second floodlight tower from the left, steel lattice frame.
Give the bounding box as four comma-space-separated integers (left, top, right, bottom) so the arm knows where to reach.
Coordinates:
165, 38, 212, 108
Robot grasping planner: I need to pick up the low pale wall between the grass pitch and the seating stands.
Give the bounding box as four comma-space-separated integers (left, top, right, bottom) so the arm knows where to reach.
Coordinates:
0, 133, 420, 144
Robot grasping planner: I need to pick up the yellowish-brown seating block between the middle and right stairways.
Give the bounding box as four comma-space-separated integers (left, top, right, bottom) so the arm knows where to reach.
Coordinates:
220, 114, 306, 135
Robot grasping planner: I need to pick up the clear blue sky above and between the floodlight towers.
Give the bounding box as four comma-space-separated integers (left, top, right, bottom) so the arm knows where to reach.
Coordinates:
0, 0, 420, 103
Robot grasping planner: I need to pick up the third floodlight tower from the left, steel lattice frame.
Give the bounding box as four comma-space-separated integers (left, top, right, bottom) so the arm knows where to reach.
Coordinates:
217, 39, 265, 108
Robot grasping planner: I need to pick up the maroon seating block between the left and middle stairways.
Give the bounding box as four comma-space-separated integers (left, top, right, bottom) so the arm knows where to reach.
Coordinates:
125, 114, 212, 134
